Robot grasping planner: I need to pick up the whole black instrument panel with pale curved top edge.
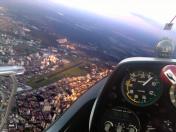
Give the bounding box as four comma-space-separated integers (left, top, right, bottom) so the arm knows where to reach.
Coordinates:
92, 58, 176, 132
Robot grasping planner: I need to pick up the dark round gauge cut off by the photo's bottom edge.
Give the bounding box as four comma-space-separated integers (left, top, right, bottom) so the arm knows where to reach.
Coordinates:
99, 107, 141, 132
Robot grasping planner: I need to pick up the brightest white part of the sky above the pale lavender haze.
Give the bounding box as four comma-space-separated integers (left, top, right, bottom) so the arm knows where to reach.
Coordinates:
50, 0, 176, 25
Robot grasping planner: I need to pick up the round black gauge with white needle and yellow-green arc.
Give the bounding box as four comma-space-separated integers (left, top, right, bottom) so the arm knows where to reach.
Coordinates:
122, 71, 162, 107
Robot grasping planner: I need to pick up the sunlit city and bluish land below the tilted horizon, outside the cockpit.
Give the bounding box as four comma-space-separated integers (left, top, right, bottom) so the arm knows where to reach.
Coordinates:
0, 0, 173, 132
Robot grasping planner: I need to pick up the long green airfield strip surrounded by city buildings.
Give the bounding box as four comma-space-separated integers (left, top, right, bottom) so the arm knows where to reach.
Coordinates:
27, 64, 87, 88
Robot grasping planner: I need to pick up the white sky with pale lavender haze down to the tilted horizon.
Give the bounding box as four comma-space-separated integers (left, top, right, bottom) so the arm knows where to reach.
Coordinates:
46, 0, 176, 39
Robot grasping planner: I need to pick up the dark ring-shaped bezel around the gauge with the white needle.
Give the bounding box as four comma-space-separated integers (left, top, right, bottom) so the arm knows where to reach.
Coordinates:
121, 69, 163, 107
